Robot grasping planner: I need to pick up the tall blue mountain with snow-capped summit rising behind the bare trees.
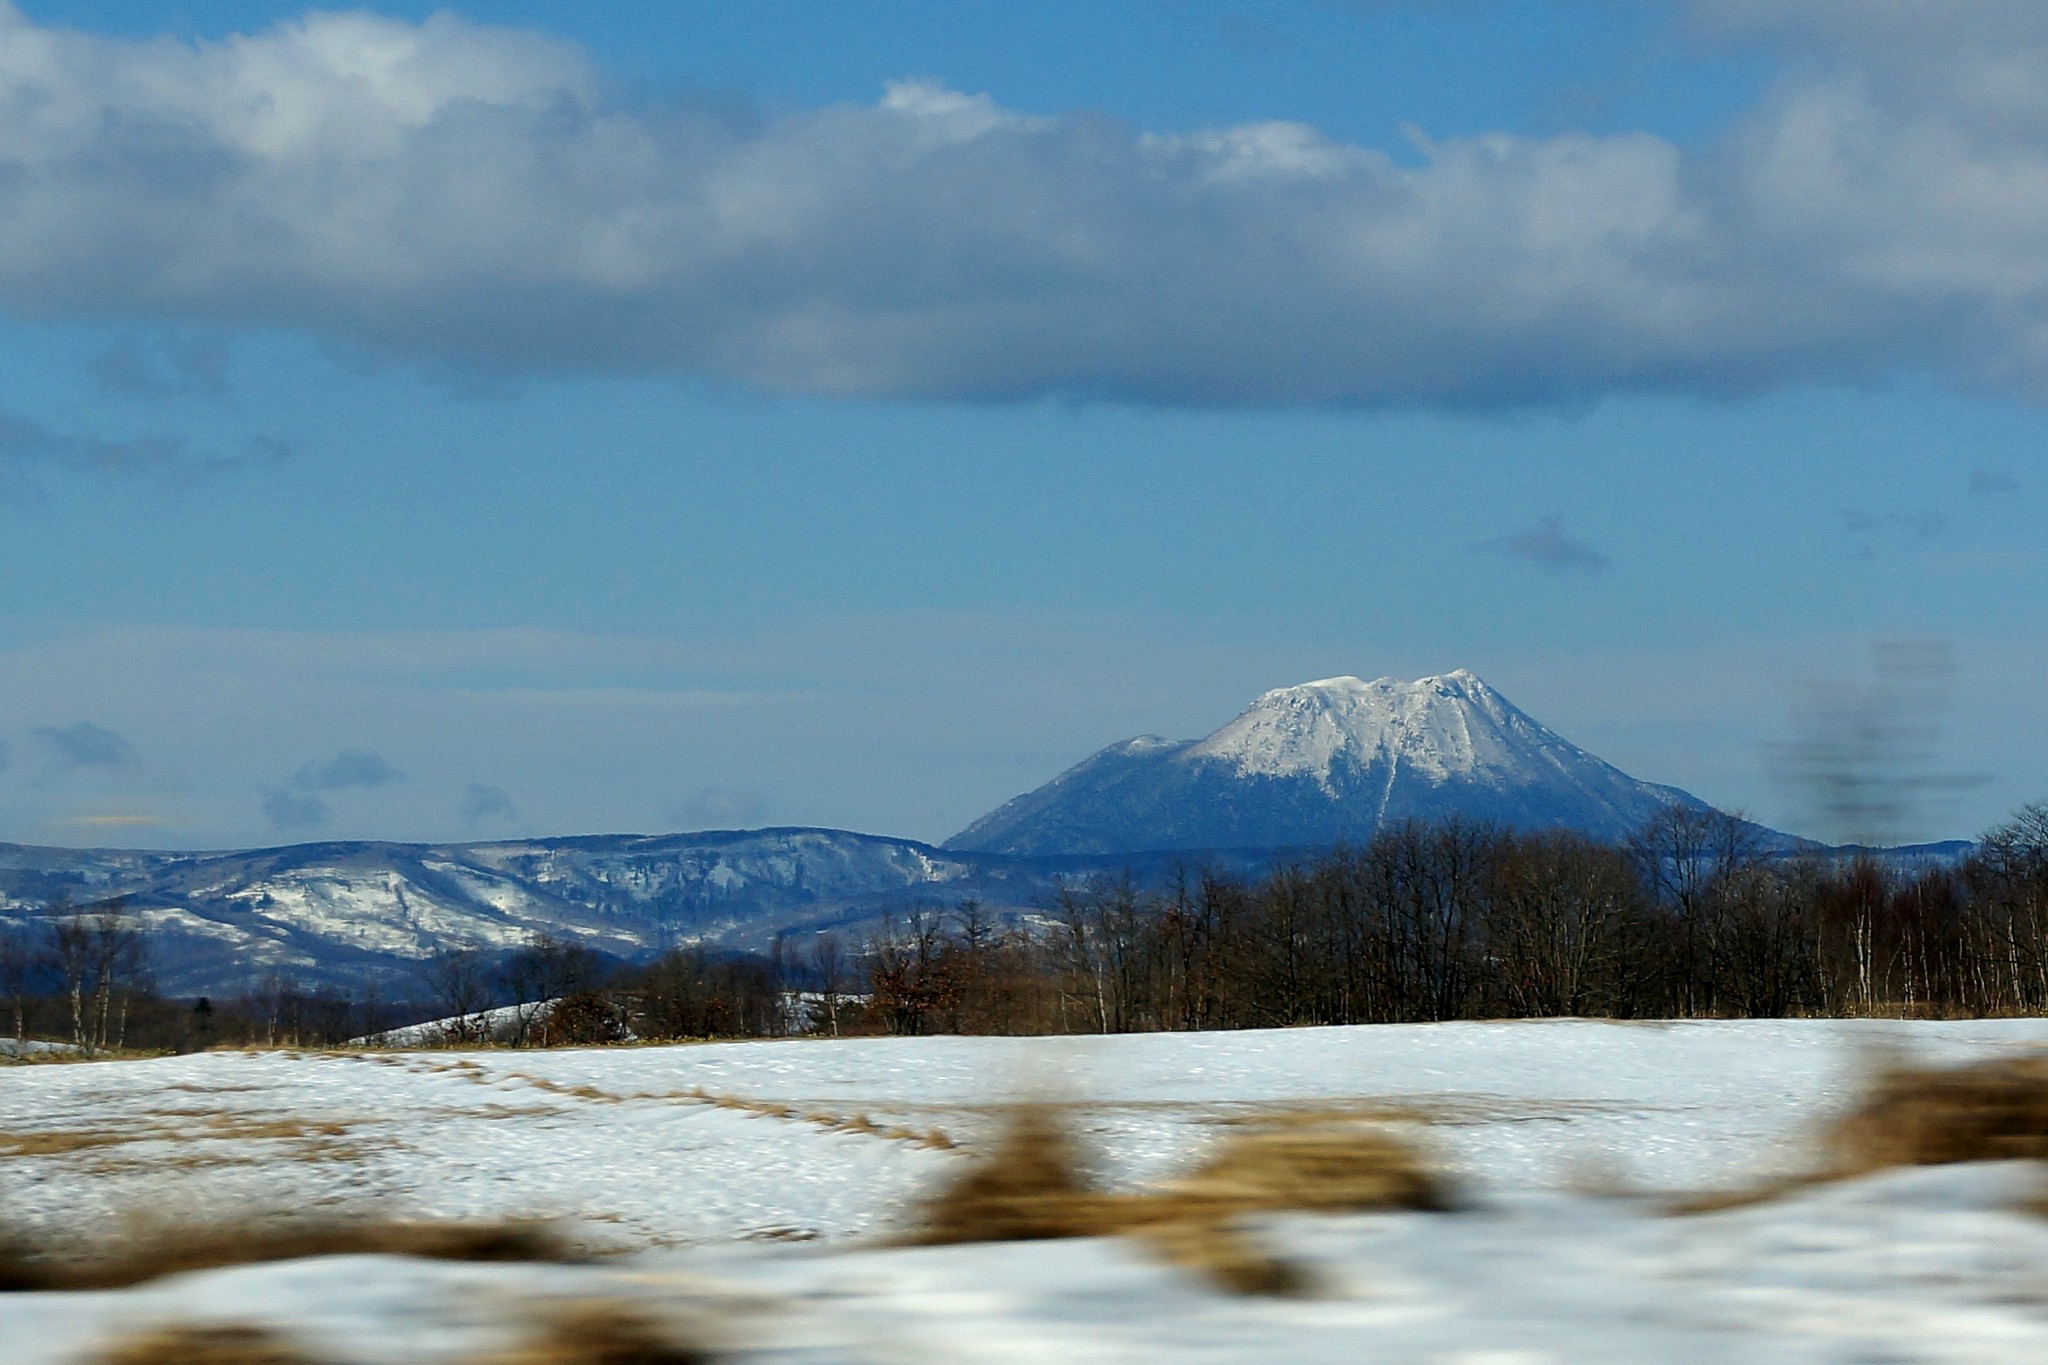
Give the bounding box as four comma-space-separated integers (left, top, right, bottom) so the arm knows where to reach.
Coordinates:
944, 669, 1704, 853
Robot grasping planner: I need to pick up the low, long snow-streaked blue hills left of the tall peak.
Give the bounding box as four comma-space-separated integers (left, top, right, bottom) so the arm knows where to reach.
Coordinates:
0, 829, 1277, 995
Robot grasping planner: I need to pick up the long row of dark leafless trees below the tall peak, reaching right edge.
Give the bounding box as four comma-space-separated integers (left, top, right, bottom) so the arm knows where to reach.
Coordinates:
856, 806, 2048, 1033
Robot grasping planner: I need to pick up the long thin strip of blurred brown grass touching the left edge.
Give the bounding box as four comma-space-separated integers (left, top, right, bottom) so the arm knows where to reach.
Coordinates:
0, 1218, 580, 1291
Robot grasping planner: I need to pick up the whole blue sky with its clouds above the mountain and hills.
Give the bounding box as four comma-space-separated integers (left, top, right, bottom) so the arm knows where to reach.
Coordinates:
0, 0, 2048, 847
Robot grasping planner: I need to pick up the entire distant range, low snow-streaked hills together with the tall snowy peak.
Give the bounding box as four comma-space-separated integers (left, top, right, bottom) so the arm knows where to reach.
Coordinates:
0, 671, 1968, 995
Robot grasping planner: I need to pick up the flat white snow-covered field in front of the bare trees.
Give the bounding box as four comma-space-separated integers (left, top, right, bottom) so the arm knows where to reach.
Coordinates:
0, 1021, 2048, 1365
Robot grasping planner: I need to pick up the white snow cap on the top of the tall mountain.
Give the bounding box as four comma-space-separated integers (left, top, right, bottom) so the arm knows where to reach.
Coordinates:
1188, 669, 1569, 794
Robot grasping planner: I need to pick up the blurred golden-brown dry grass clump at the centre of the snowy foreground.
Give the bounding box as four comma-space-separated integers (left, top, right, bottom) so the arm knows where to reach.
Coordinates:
903, 1105, 1452, 1293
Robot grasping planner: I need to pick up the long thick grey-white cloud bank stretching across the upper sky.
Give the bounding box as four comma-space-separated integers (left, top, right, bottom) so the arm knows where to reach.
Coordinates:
0, 0, 2048, 407
